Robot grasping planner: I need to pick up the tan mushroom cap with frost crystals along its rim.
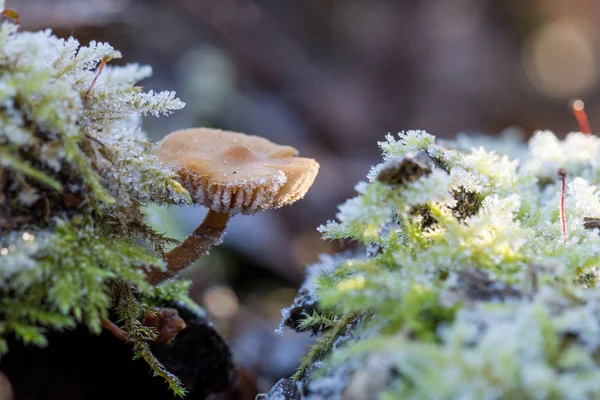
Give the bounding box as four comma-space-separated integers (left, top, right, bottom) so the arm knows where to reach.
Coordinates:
156, 128, 319, 215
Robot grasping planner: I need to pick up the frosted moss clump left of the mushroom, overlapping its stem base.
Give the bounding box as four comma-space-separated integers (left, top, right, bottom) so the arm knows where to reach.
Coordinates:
0, 1, 200, 394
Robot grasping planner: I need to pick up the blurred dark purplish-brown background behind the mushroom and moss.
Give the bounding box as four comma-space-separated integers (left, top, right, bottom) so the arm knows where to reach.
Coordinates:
14, 0, 600, 399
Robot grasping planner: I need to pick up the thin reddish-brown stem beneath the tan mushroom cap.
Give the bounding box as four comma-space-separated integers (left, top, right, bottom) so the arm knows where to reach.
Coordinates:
146, 210, 229, 285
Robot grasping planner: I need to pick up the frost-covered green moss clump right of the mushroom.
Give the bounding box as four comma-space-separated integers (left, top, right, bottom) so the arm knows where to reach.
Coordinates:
276, 131, 600, 399
